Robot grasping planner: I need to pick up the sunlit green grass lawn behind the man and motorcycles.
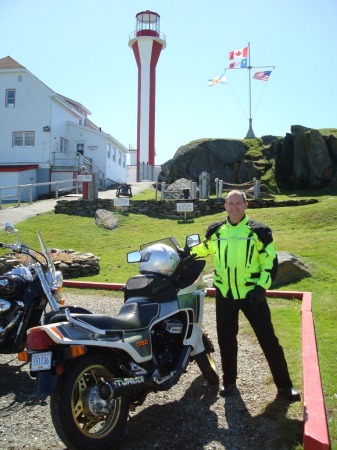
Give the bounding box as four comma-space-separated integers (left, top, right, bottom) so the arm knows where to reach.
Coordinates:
0, 190, 337, 450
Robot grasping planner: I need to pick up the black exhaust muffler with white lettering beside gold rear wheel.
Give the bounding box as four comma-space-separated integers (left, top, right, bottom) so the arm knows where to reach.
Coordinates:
98, 376, 146, 401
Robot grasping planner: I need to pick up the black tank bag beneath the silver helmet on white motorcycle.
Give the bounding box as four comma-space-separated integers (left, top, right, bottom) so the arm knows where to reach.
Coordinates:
123, 275, 177, 303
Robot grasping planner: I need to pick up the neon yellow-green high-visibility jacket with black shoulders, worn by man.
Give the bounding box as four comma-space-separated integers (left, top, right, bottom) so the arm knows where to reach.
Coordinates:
191, 216, 277, 299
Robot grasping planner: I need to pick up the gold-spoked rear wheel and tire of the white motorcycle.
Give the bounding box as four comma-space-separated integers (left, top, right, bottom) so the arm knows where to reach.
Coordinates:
50, 354, 129, 450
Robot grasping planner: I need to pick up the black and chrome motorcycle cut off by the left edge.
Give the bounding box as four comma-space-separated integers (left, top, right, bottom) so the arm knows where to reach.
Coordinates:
0, 223, 89, 354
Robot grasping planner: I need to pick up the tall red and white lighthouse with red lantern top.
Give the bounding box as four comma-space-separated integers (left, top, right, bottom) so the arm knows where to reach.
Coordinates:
129, 10, 166, 181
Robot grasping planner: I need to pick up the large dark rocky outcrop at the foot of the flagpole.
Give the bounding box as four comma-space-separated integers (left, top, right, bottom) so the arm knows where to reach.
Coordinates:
158, 125, 337, 189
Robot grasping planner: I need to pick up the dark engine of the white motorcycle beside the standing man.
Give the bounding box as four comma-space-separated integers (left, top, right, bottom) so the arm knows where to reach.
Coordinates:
152, 319, 184, 376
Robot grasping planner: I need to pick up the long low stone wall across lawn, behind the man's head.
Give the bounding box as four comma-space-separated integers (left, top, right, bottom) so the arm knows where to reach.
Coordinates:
55, 199, 318, 219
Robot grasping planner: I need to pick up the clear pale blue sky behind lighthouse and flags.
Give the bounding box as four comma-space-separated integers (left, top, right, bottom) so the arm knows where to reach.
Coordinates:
0, 0, 337, 164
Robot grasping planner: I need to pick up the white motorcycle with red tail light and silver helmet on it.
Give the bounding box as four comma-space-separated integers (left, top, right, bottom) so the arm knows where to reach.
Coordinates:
26, 235, 219, 450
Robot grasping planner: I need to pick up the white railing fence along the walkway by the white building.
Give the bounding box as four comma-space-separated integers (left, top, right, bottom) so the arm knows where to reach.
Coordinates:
0, 179, 78, 209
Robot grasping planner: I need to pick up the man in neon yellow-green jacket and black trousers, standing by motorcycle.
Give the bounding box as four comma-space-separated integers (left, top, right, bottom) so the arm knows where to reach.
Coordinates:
191, 190, 300, 401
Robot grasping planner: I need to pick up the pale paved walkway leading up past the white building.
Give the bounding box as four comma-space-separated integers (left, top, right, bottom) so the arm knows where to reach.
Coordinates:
0, 181, 153, 229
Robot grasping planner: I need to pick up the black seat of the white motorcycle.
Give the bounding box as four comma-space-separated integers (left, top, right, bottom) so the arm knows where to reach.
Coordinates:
49, 302, 159, 332
